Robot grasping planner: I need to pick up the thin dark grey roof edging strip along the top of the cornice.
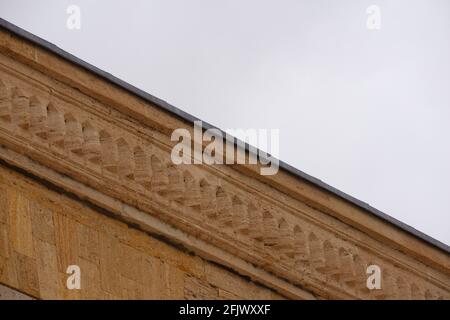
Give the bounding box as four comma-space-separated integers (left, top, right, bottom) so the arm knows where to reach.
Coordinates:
0, 18, 450, 253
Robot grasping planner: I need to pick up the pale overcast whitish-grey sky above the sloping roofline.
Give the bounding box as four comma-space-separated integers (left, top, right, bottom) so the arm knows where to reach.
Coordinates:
0, 0, 450, 244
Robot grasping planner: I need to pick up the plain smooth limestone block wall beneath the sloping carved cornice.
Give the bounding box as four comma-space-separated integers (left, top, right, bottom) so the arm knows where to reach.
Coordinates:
0, 166, 282, 299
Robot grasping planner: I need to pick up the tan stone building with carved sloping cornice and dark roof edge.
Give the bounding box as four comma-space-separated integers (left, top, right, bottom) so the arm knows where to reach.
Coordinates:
0, 20, 450, 299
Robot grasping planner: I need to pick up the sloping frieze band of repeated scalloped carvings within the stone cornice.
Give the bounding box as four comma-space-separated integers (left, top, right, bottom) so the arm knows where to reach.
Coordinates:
0, 55, 450, 299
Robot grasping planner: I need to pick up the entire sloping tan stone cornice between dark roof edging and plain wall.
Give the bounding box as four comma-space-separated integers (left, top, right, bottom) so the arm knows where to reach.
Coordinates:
0, 25, 450, 299
